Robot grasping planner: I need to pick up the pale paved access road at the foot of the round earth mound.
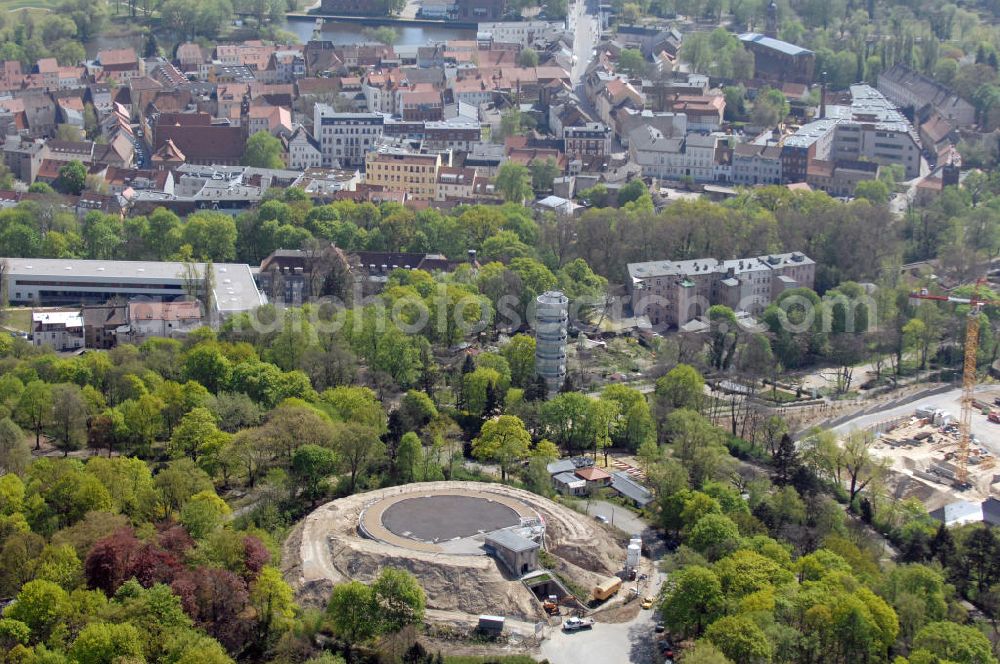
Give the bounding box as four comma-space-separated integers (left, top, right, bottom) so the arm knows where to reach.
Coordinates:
541, 575, 665, 664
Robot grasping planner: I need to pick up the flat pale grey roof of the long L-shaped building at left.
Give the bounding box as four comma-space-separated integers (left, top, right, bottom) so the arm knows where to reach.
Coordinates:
0, 258, 267, 312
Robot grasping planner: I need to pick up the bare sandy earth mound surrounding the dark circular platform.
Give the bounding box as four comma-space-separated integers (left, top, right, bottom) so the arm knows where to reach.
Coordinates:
282, 482, 625, 621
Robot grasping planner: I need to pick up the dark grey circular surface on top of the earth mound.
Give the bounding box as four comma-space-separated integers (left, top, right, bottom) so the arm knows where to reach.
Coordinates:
382, 494, 521, 542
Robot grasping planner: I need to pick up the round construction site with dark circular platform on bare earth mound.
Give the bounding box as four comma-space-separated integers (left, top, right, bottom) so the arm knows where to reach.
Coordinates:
282, 482, 653, 625
